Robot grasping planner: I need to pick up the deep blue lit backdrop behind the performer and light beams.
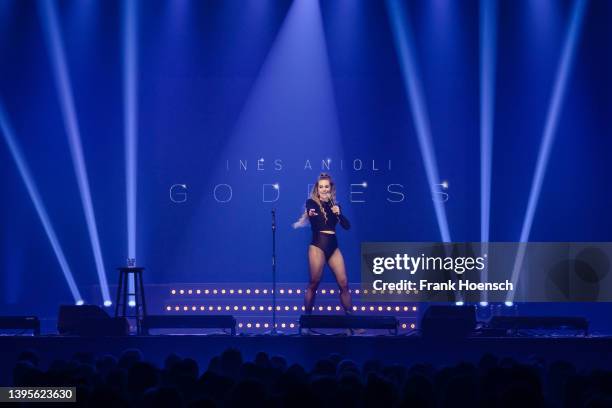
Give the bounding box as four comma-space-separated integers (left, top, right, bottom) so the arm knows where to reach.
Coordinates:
0, 0, 612, 313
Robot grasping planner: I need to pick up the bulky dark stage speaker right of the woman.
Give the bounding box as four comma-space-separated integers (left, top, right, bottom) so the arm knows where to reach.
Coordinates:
421, 306, 476, 339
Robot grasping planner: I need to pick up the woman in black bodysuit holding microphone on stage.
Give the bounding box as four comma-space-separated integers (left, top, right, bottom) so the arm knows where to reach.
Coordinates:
293, 173, 352, 314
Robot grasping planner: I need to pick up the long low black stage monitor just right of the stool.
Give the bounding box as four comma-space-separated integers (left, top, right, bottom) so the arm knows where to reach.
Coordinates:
143, 315, 236, 336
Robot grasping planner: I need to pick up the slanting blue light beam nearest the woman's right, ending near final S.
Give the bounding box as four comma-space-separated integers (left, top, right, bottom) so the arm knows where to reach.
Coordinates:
387, 0, 451, 242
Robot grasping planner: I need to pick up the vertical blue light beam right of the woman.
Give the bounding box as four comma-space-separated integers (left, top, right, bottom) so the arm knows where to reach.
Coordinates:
480, 0, 497, 304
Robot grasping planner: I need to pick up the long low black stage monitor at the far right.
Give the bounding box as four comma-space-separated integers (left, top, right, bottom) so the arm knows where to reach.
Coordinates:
487, 316, 589, 336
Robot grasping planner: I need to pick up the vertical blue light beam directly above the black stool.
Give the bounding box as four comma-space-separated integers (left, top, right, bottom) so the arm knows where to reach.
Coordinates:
122, 1, 138, 306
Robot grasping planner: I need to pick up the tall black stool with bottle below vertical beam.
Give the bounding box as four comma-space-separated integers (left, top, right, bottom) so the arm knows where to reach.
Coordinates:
115, 267, 147, 335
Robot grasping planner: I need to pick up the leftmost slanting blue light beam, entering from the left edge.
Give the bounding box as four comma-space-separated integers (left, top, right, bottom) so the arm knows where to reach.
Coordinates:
0, 101, 83, 303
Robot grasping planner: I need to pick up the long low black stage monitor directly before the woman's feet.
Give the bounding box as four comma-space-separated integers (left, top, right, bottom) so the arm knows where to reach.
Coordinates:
300, 315, 398, 334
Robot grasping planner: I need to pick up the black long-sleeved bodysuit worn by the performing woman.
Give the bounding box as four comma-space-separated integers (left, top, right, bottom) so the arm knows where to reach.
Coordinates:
306, 198, 351, 261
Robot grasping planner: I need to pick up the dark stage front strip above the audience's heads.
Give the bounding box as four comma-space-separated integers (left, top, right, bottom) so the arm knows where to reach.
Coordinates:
0, 335, 612, 385
